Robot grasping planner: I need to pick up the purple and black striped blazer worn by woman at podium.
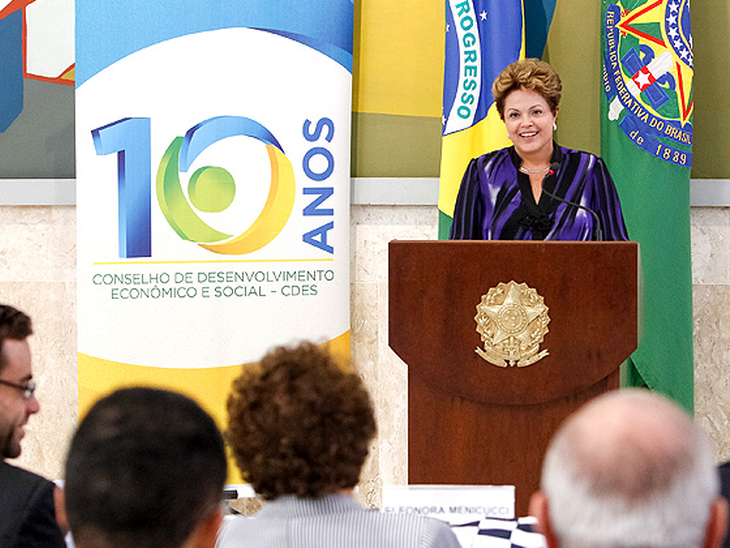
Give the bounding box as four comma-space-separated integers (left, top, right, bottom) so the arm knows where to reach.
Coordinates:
450, 144, 629, 241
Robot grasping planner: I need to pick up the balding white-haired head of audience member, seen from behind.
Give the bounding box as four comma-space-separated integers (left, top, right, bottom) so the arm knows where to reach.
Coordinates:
530, 390, 727, 548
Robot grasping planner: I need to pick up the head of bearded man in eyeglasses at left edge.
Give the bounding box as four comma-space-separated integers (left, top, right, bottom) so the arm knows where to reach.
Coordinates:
0, 304, 40, 459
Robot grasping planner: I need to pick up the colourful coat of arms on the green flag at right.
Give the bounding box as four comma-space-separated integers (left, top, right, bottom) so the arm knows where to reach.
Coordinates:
603, 0, 694, 167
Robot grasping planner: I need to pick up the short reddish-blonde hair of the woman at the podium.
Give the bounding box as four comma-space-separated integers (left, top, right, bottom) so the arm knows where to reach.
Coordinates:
492, 58, 563, 120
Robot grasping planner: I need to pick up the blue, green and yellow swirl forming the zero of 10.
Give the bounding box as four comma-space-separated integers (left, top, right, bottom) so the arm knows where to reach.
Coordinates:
156, 116, 296, 255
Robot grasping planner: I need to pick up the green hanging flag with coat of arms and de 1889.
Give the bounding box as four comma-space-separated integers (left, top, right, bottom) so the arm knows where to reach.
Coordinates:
601, 0, 694, 412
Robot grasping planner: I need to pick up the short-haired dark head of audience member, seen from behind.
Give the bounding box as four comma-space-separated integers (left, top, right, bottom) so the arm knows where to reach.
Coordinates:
65, 388, 226, 548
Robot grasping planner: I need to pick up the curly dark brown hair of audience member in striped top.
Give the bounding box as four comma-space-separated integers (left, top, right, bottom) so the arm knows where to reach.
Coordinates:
227, 343, 376, 500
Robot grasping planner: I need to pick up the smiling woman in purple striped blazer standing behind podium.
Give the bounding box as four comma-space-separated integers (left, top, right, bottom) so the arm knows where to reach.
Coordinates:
450, 59, 628, 240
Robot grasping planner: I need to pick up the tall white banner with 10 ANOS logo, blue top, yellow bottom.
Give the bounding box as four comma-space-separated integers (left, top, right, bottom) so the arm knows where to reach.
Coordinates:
76, 0, 354, 480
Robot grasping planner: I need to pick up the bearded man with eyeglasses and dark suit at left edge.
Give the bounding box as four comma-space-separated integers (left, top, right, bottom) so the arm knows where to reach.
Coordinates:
0, 304, 66, 548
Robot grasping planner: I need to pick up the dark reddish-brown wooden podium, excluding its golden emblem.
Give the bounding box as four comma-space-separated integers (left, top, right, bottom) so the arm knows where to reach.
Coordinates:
388, 241, 638, 516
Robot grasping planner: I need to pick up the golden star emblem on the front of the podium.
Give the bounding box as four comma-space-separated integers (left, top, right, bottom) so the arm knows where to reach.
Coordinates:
474, 280, 550, 367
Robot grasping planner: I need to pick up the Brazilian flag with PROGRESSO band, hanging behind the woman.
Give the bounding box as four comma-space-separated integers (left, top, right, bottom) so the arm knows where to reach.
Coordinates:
438, 0, 555, 240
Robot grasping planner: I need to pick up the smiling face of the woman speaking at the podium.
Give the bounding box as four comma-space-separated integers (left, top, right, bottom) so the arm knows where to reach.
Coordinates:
504, 89, 557, 158
